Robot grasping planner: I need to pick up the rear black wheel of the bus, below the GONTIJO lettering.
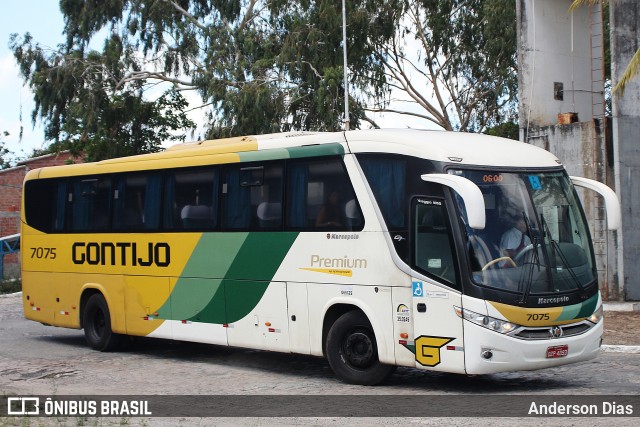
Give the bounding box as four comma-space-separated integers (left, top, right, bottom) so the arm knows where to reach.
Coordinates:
82, 294, 124, 351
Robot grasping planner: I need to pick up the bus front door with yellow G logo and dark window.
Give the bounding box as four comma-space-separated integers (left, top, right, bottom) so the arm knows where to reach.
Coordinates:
411, 197, 464, 373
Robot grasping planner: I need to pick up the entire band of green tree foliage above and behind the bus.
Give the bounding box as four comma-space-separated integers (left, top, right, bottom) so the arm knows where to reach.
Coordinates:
10, 0, 516, 147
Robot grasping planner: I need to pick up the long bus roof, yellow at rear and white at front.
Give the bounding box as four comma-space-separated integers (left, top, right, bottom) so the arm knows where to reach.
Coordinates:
27, 129, 561, 179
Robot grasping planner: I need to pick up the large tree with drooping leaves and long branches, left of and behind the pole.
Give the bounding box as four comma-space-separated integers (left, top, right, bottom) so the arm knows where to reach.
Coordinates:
11, 0, 401, 149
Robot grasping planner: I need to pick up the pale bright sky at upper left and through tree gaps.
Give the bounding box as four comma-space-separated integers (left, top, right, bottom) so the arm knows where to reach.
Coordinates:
0, 0, 429, 163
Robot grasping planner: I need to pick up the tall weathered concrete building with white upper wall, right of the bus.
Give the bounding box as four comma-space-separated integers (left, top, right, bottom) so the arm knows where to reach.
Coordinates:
516, 0, 640, 300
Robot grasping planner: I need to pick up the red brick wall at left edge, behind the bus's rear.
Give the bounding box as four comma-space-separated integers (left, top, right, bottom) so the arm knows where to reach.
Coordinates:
0, 151, 80, 279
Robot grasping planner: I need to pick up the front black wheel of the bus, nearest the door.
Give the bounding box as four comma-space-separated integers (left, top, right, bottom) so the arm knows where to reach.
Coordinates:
326, 310, 396, 385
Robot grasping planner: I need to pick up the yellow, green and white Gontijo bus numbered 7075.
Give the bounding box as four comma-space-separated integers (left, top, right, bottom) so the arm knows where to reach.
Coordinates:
21, 130, 620, 385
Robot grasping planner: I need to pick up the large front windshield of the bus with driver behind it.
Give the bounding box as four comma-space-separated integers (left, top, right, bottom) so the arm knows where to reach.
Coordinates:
454, 170, 597, 302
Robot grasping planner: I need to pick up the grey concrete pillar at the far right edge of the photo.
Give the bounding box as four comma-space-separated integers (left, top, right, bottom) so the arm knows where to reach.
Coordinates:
609, 0, 640, 300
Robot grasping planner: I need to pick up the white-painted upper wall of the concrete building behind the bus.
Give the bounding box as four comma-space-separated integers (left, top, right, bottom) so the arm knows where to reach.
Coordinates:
517, 0, 593, 129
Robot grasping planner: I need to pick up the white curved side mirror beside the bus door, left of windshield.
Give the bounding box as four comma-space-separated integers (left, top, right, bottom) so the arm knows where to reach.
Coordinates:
420, 173, 487, 230
